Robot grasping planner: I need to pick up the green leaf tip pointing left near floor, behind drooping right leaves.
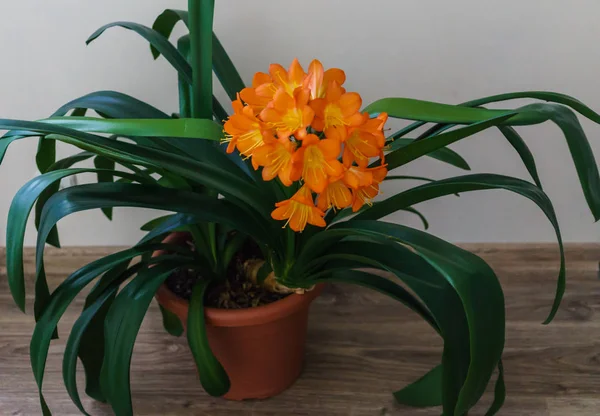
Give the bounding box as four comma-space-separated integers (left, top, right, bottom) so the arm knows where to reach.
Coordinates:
394, 365, 443, 407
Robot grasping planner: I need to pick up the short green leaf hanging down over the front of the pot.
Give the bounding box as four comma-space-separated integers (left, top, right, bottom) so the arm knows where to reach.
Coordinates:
187, 280, 231, 396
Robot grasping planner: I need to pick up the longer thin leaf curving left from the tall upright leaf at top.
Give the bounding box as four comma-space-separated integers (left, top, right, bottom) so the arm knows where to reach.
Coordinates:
86, 22, 192, 84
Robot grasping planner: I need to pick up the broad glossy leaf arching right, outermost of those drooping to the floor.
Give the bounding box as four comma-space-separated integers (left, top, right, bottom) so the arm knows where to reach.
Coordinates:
332, 220, 504, 415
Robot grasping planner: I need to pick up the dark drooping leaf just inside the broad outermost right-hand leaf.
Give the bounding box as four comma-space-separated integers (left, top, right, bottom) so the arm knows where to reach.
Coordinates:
298, 234, 480, 415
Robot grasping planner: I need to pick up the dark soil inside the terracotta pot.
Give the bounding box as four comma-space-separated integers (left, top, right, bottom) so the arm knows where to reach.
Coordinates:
165, 237, 287, 309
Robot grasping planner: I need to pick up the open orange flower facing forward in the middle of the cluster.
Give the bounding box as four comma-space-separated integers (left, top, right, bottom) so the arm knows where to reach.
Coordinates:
292, 134, 344, 193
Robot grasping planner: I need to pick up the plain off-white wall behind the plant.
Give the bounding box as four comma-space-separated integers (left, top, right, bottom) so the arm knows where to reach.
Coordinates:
0, 0, 600, 245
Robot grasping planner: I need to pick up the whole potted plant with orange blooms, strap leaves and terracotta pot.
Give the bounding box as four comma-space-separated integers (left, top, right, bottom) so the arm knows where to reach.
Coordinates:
0, 0, 600, 415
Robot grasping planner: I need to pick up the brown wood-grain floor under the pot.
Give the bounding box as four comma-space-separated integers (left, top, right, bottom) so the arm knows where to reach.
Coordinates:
0, 245, 600, 416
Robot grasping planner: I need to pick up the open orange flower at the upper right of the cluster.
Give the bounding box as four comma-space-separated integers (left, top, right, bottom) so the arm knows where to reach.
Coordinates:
310, 81, 365, 135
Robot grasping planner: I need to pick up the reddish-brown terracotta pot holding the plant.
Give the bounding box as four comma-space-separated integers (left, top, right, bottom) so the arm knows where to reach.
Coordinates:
156, 233, 323, 400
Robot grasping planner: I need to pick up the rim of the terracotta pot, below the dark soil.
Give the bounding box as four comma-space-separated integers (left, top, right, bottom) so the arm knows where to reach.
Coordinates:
156, 284, 324, 327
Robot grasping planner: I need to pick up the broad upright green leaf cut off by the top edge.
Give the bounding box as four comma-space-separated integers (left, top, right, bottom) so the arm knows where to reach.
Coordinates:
188, 0, 215, 119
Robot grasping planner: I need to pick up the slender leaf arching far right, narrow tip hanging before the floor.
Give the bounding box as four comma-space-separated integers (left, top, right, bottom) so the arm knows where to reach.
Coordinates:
353, 174, 566, 323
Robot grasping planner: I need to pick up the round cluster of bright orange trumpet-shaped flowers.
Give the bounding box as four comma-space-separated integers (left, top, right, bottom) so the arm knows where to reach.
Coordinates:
225, 59, 387, 231
